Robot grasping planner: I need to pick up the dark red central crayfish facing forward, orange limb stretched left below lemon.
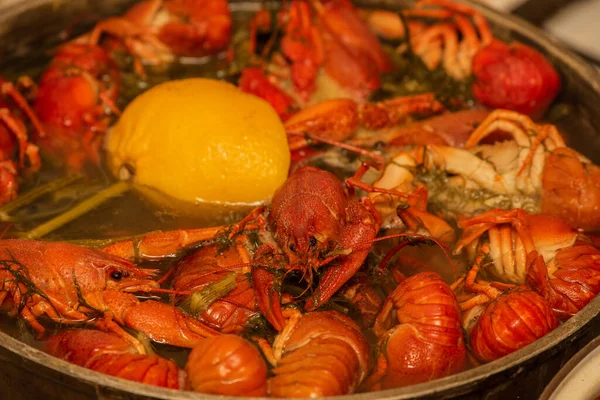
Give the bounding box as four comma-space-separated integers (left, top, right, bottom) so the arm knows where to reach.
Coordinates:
104, 167, 379, 330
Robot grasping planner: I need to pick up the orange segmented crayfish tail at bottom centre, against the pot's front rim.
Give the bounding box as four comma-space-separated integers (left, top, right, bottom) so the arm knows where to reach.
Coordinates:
263, 311, 369, 398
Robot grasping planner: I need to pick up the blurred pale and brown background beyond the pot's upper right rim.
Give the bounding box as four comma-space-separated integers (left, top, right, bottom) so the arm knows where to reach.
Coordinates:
479, 0, 600, 64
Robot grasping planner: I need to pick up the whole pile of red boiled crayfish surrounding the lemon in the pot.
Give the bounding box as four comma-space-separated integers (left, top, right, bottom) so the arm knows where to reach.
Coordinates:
0, 0, 600, 397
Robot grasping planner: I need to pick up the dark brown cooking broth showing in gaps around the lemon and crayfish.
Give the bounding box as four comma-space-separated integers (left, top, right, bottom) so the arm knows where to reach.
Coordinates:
0, 3, 600, 240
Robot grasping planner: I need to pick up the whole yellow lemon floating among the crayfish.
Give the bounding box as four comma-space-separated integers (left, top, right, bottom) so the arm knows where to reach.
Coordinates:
106, 79, 290, 203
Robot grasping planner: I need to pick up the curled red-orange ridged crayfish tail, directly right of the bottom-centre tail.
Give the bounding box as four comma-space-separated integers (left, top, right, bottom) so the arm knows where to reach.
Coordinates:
366, 272, 467, 390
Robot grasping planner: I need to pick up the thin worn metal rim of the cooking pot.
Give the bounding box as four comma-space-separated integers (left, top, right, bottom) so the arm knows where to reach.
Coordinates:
0, 0, 600, 400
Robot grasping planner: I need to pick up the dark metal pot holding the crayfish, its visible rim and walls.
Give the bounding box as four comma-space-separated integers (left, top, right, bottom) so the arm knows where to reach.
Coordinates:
0, 0, 600, 400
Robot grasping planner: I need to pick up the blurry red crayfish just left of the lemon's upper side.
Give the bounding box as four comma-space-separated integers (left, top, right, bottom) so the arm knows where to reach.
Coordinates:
33, 43, 120, 170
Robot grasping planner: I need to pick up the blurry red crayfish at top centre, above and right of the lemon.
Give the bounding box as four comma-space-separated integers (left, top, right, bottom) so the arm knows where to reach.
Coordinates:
240, 0, 391, 108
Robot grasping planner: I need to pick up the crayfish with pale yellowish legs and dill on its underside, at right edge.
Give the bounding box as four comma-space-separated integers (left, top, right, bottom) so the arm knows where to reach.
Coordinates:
350, 110, 600, 231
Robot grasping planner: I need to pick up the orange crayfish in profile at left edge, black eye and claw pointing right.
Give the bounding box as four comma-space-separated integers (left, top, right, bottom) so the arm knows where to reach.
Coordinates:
0, 239, 217, 349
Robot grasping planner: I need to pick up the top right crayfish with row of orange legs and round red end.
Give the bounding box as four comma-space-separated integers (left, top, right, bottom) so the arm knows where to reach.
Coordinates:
367, 0, 561, 118
